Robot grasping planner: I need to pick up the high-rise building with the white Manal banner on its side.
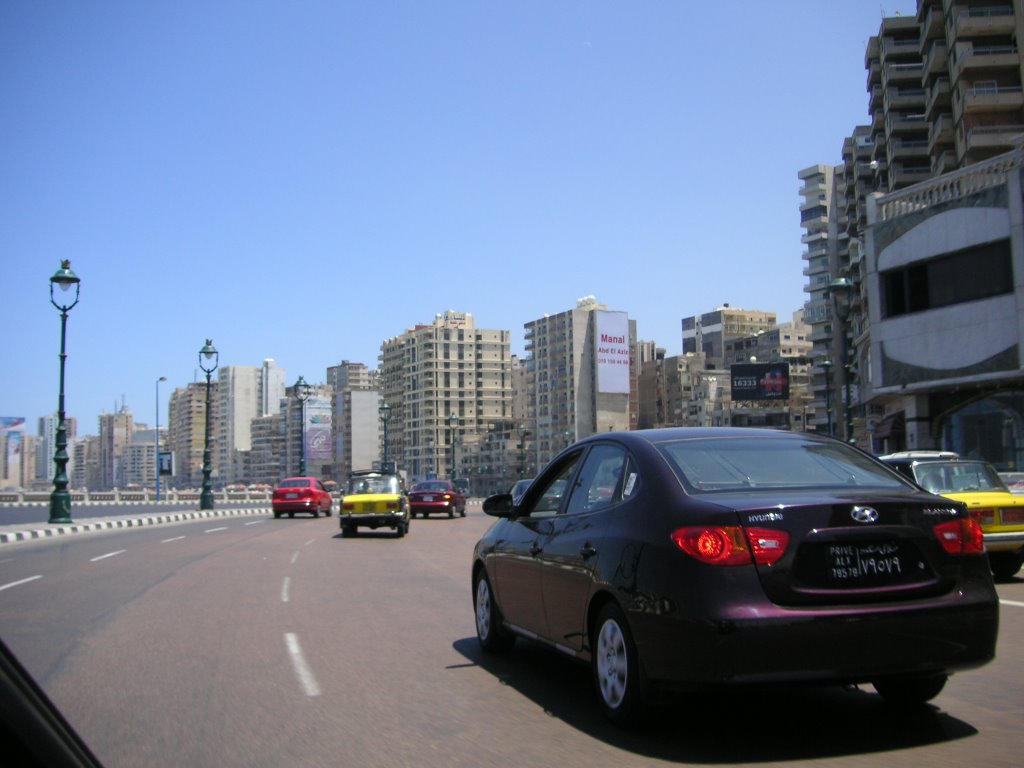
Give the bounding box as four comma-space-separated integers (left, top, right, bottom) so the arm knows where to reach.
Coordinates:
525, 296, 639, 467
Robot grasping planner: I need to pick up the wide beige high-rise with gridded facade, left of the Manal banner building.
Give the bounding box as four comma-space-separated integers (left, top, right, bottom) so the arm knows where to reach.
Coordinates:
380, 310, 512, 479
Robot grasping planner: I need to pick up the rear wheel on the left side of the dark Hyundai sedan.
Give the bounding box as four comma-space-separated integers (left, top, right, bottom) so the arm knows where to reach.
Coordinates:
591, 603, 647, 725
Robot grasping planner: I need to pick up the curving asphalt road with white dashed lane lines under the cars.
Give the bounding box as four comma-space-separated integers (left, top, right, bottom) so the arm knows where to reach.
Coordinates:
0, 508, 1024, 768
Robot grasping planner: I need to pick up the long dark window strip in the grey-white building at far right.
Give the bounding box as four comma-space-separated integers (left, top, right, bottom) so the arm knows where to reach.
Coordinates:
881, 240, 1014, 317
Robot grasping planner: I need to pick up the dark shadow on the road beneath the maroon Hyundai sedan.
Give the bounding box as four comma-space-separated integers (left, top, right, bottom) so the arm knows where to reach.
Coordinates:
453, 637, 978, 764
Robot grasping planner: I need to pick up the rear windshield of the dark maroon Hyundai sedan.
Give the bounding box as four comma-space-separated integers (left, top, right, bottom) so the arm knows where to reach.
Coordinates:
658, 435, 907, 494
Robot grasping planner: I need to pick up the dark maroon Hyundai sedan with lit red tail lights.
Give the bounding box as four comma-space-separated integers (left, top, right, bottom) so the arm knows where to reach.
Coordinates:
472, 428, 998, 722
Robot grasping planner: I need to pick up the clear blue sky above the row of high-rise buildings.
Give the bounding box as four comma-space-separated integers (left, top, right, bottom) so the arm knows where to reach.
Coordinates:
0, 0, 915, 433
